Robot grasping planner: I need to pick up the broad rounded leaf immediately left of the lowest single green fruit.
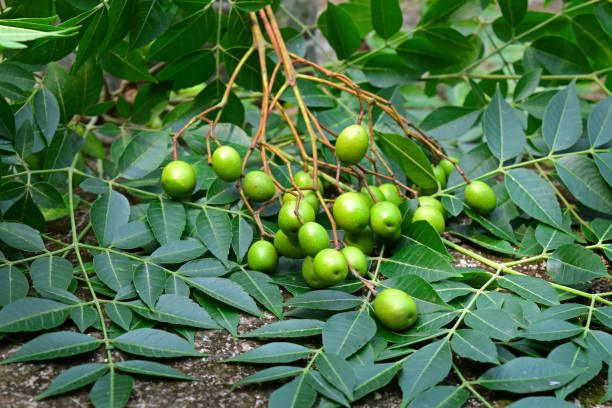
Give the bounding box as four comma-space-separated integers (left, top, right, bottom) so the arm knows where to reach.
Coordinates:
323, 308, 376, 358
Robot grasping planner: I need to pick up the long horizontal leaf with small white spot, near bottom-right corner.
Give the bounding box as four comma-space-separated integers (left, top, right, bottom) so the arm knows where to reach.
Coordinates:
477, 357, 579, 394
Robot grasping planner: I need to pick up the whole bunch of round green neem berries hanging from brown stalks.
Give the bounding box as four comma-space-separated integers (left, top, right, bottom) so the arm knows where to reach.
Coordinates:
162, 125, 496, 331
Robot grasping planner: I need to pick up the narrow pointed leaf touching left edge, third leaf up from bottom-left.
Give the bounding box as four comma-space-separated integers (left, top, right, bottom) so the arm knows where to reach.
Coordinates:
2, 331, 102, 364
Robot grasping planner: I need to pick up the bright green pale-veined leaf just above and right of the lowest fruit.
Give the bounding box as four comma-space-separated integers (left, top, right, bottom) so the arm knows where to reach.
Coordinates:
380, 244, 459, 282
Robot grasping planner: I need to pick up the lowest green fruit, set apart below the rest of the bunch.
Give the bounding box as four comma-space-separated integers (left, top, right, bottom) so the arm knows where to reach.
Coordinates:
374, 288, 418, 331
